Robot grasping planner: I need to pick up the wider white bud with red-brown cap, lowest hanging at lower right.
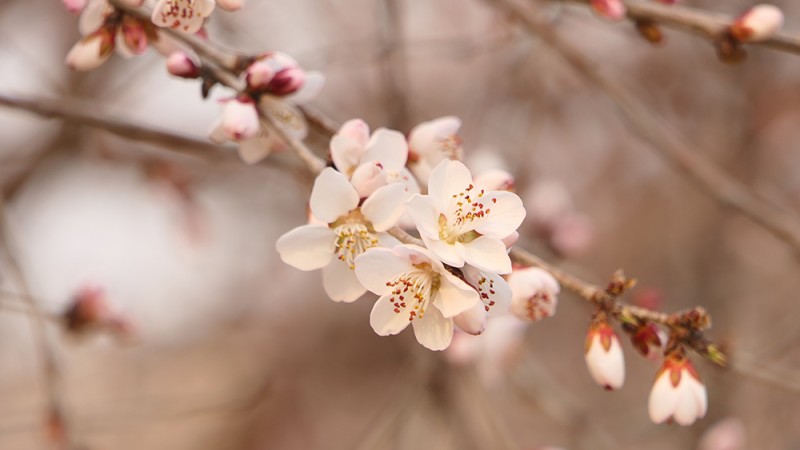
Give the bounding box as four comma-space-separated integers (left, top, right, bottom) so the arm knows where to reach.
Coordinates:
648, 350, 708, 426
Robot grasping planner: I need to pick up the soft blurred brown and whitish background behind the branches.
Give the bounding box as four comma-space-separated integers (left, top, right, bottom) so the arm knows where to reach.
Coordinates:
0, 0, 800, 450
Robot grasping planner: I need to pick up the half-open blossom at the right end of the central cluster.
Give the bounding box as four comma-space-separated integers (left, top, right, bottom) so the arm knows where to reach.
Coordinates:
508, 267, 561, 322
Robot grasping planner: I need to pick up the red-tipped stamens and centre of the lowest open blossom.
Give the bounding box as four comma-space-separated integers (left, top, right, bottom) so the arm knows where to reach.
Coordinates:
386, 263, 442, 322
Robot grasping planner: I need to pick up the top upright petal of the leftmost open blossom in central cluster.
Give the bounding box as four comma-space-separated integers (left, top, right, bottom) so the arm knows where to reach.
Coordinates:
309, 167, 360, 223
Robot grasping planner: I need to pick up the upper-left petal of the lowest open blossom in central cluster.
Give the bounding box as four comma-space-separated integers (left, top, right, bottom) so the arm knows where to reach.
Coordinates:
355, 248, 414, 296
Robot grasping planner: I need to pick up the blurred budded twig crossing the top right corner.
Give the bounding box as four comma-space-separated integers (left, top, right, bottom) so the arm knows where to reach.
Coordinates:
556, 0, 800, 55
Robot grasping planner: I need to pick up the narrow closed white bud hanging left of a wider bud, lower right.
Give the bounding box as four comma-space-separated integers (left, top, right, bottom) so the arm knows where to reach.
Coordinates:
585, 314, 625, 391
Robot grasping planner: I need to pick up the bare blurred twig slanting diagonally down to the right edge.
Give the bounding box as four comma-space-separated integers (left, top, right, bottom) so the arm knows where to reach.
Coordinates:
486, 0, 800, 258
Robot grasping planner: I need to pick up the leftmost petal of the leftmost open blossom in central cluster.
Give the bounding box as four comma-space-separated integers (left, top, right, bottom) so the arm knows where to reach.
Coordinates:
275, 225, 336, 271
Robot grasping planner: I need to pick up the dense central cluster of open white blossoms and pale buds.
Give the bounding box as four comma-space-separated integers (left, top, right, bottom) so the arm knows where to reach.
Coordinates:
276, 117, 559, 350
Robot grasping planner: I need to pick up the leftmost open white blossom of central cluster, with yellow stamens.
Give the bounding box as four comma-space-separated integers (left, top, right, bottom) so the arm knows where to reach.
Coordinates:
276, 167, 404, 302
